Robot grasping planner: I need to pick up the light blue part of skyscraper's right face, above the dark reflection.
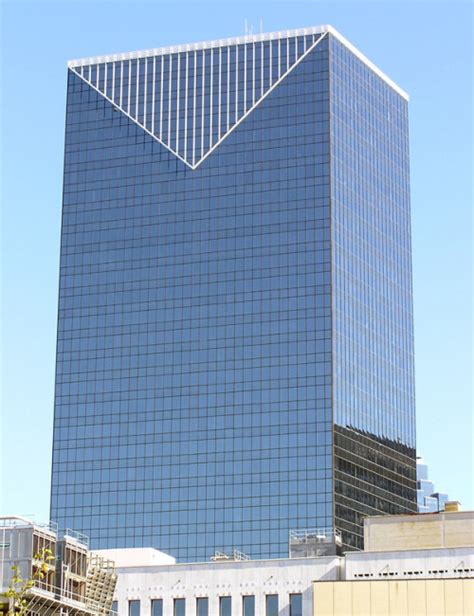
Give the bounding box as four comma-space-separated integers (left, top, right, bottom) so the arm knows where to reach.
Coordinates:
331, 38, 415, 447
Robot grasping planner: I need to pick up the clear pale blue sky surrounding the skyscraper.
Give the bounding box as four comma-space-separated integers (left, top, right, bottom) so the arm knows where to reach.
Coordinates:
0, 0, 474, 520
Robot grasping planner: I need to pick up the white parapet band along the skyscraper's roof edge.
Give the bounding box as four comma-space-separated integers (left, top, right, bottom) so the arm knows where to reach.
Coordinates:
67, 25, 409, 100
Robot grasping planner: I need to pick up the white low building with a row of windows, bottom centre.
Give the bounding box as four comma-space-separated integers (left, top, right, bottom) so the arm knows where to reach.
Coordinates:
101, 549, 341, 616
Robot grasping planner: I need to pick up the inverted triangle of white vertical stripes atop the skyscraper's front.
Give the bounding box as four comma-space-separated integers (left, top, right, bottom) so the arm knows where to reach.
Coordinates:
70, 32, 327, 169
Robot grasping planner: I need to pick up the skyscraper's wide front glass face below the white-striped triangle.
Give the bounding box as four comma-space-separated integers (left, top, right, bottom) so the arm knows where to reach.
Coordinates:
52, 39, 332, 560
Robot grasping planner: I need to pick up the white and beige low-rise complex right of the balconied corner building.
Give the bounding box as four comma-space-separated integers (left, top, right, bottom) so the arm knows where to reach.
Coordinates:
101, 512, 474, 616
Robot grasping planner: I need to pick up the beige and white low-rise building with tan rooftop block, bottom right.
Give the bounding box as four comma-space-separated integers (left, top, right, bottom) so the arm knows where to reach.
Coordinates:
313, 511, 474, 616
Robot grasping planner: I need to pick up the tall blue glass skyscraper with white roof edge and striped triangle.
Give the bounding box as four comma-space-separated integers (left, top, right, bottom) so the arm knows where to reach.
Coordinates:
51, 26, 416, 560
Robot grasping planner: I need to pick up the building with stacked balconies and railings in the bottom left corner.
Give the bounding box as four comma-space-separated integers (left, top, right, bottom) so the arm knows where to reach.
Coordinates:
0, 516, 117, 616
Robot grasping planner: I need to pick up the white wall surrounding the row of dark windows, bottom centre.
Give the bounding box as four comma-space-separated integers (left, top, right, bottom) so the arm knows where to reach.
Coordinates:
108, 550, 341, 616
